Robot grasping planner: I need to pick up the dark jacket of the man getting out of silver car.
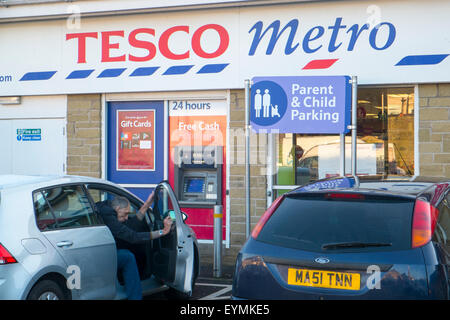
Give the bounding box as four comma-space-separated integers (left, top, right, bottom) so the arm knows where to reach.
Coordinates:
96, 200, 150, 249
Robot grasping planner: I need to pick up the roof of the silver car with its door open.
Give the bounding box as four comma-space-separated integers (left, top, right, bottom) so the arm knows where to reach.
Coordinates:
0, 174, 108, 190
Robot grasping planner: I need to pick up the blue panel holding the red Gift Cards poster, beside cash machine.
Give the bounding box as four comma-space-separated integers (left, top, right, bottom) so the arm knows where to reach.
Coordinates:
106, 101, 167, 200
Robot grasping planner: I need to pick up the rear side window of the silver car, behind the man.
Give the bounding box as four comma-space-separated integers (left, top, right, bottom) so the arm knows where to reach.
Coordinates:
34, 185, 100, 230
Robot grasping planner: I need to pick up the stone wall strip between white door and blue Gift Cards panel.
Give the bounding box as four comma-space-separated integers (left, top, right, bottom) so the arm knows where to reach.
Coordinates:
67, 94, 102, 178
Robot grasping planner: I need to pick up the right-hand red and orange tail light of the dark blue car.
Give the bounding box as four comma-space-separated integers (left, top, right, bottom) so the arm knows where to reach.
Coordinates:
411, 200, 439, 248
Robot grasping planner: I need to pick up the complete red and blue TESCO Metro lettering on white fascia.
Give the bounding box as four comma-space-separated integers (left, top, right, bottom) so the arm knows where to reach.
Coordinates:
66, 17, 396, 63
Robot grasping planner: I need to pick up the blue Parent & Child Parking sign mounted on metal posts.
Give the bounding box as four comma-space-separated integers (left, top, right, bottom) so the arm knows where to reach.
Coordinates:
250, 76, 352, 134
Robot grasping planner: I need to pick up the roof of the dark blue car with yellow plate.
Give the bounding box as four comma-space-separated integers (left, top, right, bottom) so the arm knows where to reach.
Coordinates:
290, 176, 450, 196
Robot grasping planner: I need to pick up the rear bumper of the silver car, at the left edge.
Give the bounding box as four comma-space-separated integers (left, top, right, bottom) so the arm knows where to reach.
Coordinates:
0, 263, 31, 300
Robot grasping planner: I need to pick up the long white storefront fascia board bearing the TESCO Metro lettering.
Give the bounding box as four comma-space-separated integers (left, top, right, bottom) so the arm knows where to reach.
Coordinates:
4, 0, 450, 96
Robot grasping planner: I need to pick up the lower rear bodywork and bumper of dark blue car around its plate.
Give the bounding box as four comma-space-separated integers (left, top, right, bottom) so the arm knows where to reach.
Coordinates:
232, 242, 430, 300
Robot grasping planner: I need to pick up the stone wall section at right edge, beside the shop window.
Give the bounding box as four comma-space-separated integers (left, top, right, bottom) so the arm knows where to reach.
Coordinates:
419, 84, 450, 177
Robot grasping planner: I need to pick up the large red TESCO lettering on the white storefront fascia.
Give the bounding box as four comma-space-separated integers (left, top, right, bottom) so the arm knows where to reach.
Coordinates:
66, 24, 230, 63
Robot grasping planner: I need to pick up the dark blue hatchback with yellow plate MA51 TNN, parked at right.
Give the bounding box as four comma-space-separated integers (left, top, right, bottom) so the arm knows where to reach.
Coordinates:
232, 177, 450, 300
